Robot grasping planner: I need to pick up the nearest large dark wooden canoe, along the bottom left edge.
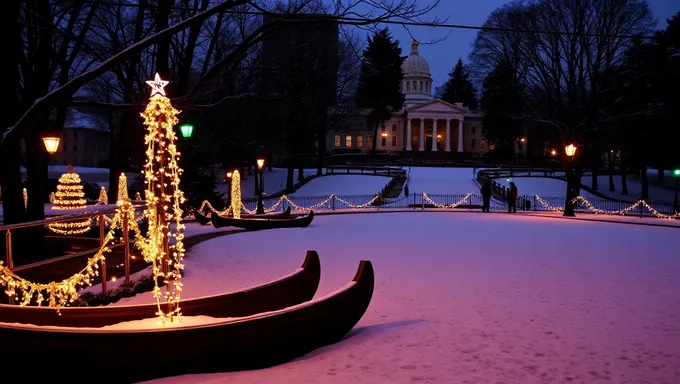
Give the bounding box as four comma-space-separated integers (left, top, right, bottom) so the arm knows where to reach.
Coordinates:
0, 261, 374, 383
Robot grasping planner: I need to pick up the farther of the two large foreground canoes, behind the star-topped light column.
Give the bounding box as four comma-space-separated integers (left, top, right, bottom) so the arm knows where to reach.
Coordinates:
0, 251, 321, 327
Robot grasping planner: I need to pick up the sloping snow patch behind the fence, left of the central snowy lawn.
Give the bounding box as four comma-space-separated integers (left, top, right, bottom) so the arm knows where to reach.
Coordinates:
291, 175, 392, 196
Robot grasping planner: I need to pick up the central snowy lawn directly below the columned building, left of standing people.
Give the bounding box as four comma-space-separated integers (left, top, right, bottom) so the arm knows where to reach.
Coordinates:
406, 167, 479, 195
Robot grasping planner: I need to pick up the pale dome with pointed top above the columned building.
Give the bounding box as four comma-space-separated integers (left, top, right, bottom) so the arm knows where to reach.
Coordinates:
401, 40, 432, 108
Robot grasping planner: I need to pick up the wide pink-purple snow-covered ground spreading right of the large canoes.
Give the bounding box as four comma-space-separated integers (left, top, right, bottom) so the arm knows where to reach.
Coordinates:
125, 213, 680, 384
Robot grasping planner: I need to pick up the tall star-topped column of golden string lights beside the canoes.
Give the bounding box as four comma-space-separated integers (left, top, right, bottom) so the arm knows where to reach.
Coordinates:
142, 74, 184, 322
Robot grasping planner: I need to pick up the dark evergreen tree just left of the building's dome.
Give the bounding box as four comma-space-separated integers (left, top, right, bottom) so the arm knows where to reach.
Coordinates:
356, 28, 405, 154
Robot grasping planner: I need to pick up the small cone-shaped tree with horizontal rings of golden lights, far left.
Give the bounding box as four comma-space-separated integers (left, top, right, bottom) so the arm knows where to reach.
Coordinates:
48, 166, 90, 235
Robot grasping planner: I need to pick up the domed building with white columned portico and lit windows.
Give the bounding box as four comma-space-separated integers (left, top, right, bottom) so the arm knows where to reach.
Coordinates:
327, 40, 489, 154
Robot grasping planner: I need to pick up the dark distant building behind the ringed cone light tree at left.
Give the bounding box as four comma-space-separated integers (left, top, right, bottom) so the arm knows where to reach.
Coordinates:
50, 111, 109, 167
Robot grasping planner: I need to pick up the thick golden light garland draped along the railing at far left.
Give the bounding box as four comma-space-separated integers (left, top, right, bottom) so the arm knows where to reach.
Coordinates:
0, 201, 140, 312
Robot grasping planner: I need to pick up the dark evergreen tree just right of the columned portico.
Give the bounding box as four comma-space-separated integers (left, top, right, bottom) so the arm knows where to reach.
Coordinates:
481, 60, 523, 148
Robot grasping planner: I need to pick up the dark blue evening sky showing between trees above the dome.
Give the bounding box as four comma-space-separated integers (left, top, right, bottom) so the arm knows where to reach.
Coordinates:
372, 0, 680, 89
